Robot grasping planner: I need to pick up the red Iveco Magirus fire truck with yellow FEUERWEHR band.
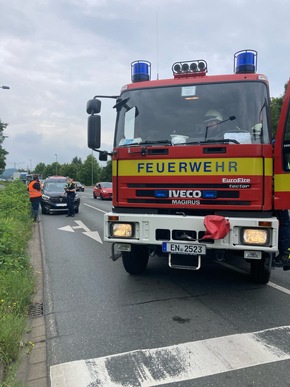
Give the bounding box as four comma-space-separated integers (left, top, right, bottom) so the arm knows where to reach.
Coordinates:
87, 50, 290, 283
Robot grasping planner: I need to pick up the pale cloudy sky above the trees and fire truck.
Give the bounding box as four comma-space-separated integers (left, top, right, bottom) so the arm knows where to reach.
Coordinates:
0, 0, 290, 169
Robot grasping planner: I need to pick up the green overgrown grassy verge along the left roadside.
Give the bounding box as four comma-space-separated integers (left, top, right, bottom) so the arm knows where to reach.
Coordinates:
0, 181, 35, 372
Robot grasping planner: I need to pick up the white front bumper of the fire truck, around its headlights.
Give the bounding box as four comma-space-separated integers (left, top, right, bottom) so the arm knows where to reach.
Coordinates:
104, 212, 278, 253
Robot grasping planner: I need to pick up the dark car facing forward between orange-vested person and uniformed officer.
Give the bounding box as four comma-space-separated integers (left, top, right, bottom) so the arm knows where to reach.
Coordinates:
41, 176, 80, 214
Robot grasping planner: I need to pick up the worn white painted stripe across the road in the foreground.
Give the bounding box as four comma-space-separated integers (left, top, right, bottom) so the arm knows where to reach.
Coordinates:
50, 326, 290, 387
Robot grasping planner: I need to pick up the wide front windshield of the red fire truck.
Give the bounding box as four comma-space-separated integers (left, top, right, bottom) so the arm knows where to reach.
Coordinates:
114, 81, 271, 146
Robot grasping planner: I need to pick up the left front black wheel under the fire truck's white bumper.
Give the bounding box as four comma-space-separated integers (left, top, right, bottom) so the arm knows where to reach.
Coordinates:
122, 245, 149, 274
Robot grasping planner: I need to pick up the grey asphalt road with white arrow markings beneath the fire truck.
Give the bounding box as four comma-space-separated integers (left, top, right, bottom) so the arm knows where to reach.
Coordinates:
41, 188, 290, 387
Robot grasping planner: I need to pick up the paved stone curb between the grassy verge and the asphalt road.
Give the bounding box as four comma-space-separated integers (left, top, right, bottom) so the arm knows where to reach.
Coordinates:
16, 223, 49, 387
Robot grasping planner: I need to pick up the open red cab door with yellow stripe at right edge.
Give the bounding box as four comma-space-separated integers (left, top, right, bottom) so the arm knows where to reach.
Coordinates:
274, 80, 290, 210
